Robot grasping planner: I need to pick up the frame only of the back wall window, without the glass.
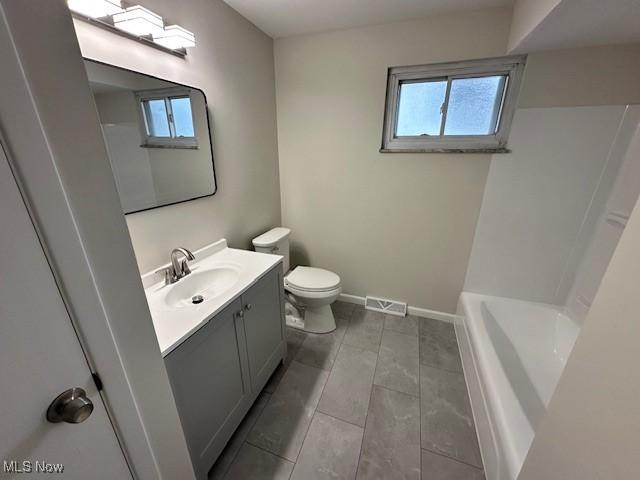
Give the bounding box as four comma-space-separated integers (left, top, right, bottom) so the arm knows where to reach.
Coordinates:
380, 55, 527, 153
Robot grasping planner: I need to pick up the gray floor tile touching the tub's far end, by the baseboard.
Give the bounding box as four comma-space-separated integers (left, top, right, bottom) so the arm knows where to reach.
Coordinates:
420, 318, 462, 372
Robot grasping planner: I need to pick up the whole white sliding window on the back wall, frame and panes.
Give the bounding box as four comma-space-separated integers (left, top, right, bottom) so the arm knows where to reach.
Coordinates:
381, 56, 526, 152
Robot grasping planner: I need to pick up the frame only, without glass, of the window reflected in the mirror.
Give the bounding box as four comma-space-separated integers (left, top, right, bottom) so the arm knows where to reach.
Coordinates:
135, 87, 198, 149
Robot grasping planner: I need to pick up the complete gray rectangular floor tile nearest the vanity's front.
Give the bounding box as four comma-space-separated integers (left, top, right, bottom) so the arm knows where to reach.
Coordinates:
247, 361, 329, 462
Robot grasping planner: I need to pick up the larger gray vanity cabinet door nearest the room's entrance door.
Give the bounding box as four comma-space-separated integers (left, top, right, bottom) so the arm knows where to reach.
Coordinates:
165, 300, 253, 478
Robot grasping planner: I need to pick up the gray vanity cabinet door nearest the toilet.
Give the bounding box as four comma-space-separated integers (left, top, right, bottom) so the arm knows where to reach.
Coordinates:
242, 265, 287, 392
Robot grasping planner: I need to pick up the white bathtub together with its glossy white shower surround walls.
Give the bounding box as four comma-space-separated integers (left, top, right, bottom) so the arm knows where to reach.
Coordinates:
456, 106, 640, 479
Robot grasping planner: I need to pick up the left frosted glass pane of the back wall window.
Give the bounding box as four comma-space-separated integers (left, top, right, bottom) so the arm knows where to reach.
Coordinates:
396, 80, 447, 137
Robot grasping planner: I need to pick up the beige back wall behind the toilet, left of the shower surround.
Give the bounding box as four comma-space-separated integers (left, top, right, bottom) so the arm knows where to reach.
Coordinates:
275, 9, 511, 312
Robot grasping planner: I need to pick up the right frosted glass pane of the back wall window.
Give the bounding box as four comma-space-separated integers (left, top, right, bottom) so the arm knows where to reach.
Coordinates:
444, 75, 506, 135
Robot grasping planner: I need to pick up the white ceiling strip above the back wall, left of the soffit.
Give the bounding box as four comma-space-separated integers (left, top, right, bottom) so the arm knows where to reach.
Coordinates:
225, 0, 514, 38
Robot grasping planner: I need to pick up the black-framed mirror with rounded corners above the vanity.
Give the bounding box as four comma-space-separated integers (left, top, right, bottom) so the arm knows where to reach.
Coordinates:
85, 59, 217, 214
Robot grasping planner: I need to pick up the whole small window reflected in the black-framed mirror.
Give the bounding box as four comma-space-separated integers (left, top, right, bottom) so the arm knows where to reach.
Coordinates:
136, 88, 198, 148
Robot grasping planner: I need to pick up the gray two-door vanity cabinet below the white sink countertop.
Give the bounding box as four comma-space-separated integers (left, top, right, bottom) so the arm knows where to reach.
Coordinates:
164, 264, 286, 479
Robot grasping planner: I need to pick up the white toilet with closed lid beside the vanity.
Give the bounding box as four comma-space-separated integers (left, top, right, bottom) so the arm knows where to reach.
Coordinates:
253, 227, 342, 333
